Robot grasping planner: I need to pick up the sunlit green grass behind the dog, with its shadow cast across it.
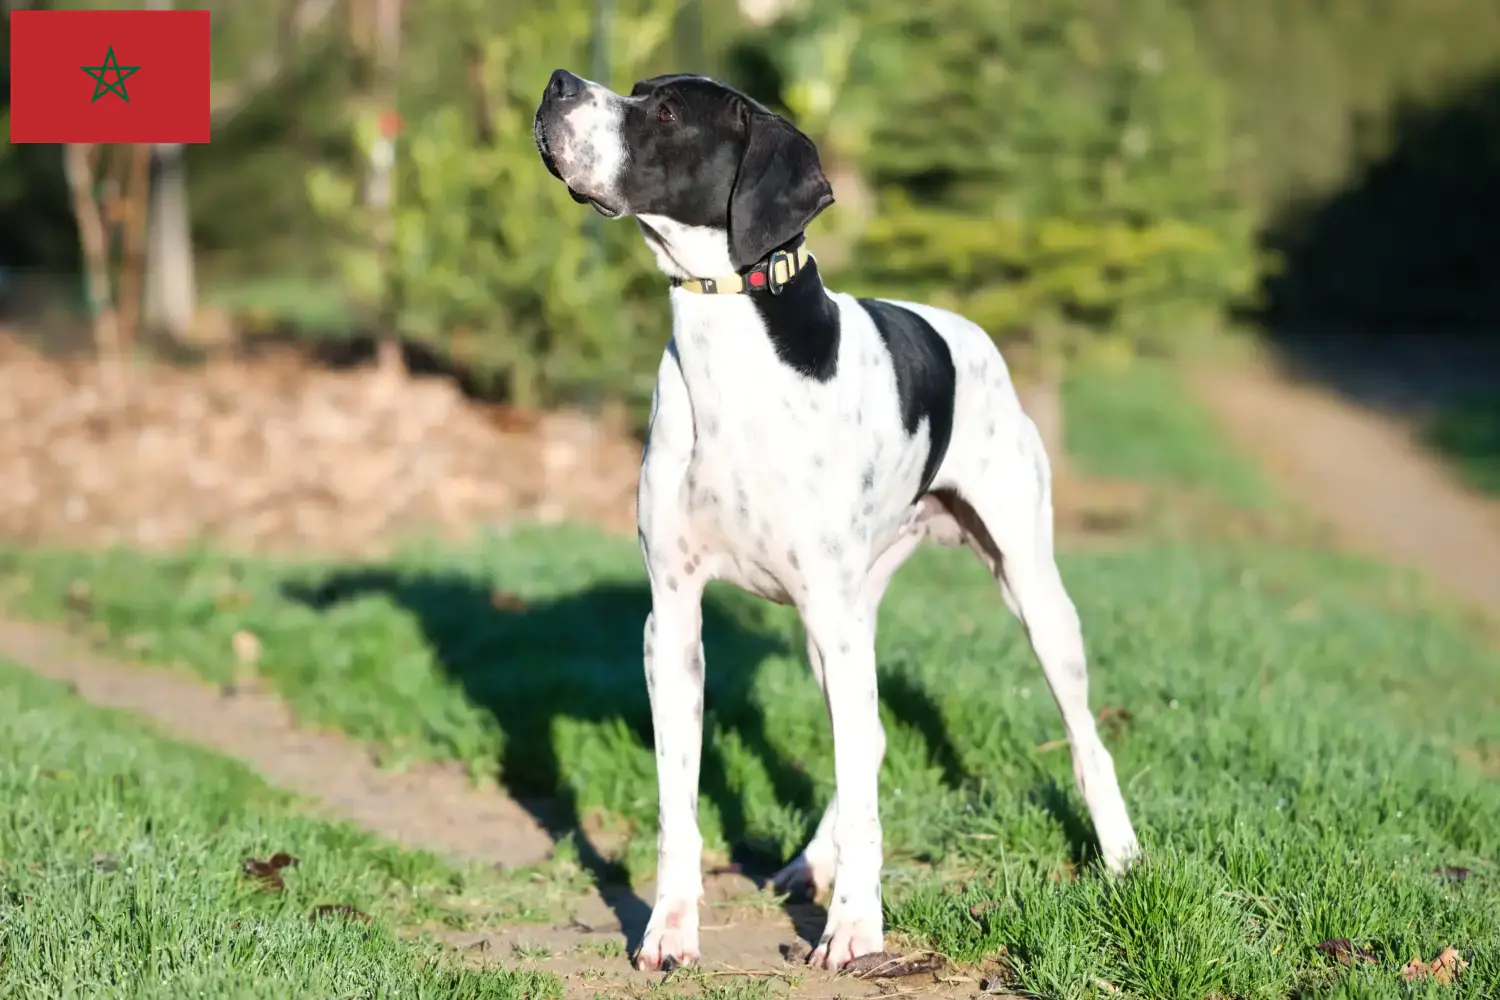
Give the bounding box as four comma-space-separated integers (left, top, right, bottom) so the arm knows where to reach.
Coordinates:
0, 529, 1500, 1000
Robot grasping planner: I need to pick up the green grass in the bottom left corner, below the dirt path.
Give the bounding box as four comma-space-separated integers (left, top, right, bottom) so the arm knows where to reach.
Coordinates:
0, 664, 561, 1000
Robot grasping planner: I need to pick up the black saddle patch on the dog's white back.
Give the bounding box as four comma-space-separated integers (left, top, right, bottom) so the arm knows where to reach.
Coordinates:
860, 298, 959, 496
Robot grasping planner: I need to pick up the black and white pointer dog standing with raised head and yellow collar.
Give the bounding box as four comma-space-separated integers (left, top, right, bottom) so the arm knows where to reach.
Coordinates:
534, 69, 1137, 969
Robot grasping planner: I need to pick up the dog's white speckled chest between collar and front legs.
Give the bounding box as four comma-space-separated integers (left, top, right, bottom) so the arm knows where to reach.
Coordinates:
674, 290, 921, 603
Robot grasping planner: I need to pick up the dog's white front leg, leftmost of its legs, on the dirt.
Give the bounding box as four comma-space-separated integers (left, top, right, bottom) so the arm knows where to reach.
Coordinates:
636, 559, 704, 970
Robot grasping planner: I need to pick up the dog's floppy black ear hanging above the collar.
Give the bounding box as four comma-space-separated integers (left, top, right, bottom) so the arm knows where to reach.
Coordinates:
729, 111, 834, 270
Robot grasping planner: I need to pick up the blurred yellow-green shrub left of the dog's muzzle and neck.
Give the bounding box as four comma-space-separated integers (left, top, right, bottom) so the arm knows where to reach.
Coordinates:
308, 0, 678, 405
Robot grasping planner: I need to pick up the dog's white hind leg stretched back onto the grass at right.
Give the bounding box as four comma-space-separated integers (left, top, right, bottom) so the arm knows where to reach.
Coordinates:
945, 420, 1140, 873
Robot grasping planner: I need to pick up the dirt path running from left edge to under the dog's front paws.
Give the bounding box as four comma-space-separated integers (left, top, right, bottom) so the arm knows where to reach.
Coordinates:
0, 619, 984, 1000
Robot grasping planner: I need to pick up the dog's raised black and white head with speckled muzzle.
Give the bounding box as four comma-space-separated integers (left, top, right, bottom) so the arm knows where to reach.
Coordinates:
533, 69, 834, 277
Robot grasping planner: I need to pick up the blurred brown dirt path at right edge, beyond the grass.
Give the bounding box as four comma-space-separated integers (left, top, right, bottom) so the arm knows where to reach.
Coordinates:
1196, 352, 1500, 621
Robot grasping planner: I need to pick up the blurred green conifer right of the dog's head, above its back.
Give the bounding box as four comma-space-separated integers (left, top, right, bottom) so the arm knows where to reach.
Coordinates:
738, 0, 1256, 358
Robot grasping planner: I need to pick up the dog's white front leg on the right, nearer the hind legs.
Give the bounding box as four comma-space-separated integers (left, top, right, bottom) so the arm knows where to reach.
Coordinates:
803, 600, 885, 969
